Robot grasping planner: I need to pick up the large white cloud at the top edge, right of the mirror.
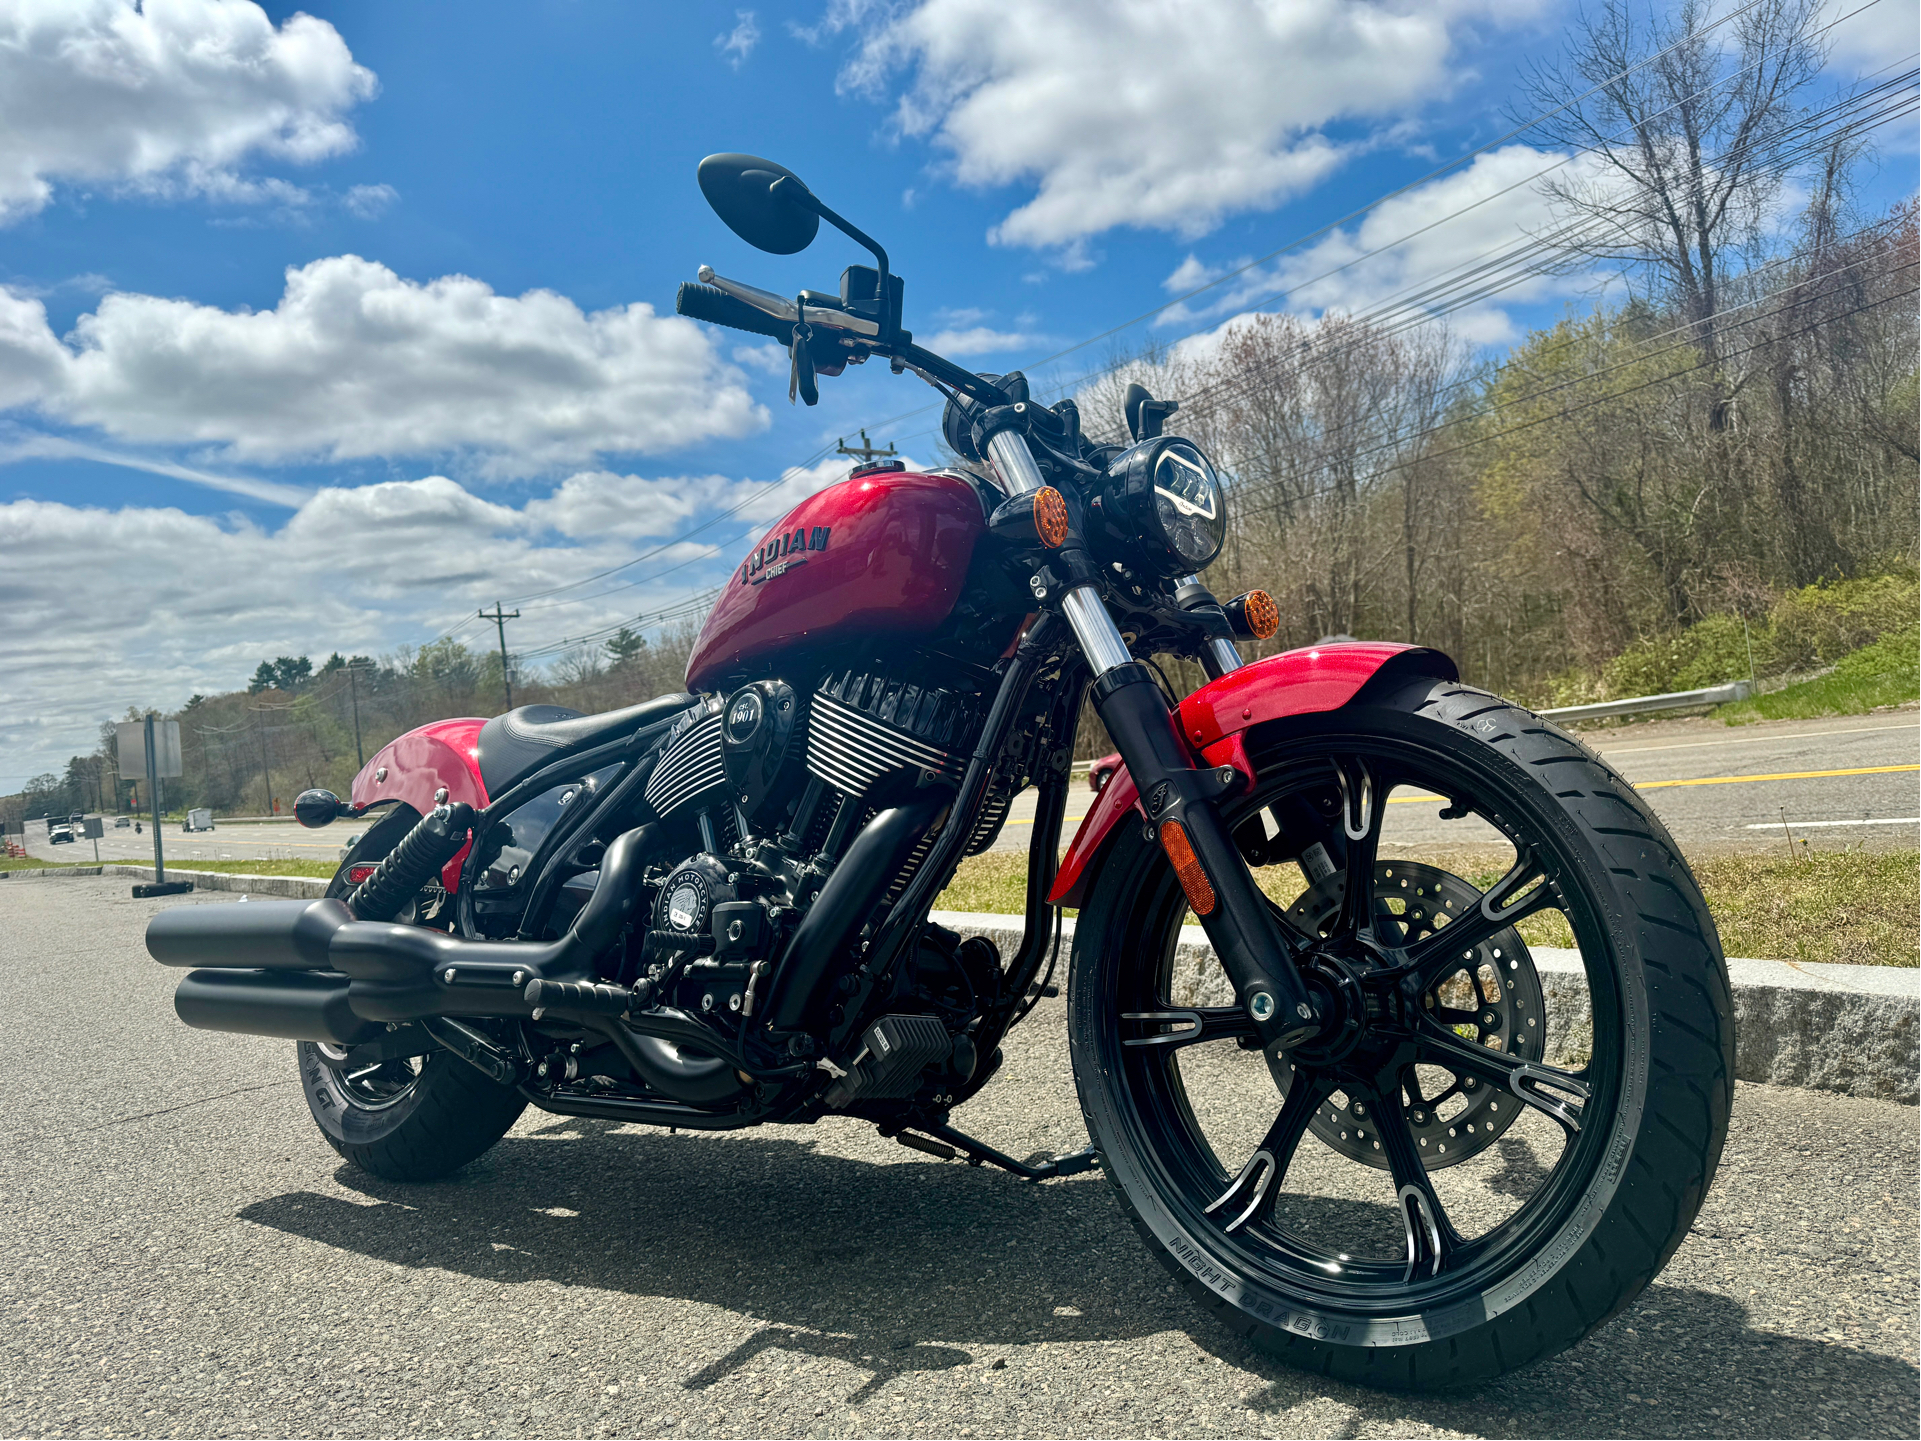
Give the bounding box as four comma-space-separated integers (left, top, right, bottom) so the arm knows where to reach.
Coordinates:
833, 0, 1531, 249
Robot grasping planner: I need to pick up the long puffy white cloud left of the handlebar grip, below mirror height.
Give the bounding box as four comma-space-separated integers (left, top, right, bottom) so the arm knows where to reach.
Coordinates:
0, 256, 766, 476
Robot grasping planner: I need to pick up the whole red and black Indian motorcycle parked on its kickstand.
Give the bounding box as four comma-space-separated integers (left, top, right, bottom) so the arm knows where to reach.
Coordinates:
148, 156, 1733, 1387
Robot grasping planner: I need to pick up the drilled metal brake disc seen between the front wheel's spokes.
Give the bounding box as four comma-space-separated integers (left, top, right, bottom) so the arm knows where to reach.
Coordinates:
1268, 861, 1546, 1170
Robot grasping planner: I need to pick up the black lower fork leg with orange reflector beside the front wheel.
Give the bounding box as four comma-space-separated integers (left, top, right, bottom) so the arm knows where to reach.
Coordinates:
1093, 661, 1320, 1049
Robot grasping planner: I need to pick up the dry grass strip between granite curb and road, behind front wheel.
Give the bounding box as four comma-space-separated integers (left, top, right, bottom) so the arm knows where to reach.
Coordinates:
934, 849, 1921, 966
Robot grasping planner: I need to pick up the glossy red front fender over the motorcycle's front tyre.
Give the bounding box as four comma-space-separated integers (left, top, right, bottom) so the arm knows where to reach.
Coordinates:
1047, 640, 1460, 907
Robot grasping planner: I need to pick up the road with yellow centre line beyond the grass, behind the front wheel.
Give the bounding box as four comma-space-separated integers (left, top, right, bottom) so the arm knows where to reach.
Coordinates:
993, 707, 1921, 853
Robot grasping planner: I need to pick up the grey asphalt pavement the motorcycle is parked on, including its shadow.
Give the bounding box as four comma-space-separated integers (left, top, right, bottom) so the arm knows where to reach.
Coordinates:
0, 876, 1921, 1437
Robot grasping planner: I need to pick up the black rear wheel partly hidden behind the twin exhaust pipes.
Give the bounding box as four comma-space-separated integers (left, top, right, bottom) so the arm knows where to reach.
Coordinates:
298, 807, 526, 1182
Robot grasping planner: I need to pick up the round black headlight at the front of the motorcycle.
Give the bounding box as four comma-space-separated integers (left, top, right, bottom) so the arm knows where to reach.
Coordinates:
1101, 436, 1228, 578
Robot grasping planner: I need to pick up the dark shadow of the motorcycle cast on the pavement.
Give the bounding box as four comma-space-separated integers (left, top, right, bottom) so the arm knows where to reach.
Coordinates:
238, 1120, 1921, 1435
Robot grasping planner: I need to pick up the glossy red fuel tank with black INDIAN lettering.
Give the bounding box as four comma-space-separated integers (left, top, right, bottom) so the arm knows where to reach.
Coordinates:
688, 471, 987, 690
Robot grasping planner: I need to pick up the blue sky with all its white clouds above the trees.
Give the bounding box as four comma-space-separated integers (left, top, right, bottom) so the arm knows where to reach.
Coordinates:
0, 0, 1915, 790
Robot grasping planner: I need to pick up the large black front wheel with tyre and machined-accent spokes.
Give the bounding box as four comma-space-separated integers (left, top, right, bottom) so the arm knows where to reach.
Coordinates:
1068, 682, 1735, 1389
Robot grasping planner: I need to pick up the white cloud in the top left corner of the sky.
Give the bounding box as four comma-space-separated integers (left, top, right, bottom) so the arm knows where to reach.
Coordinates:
0, 0, 377, 223
